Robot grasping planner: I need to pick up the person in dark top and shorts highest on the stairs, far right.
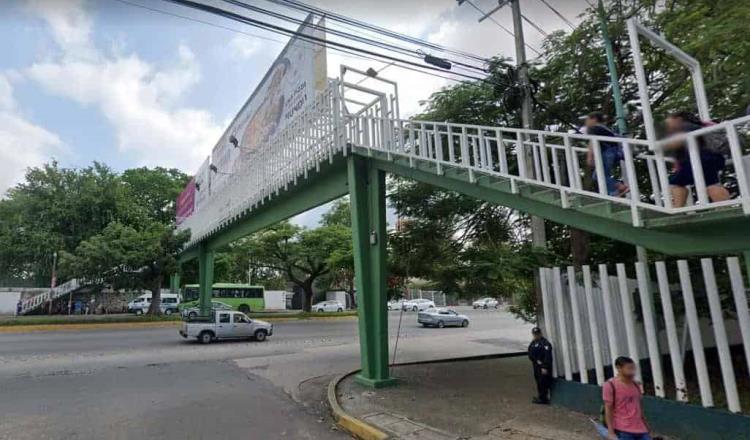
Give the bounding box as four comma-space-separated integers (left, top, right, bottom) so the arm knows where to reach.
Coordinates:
665, 111, 731, 208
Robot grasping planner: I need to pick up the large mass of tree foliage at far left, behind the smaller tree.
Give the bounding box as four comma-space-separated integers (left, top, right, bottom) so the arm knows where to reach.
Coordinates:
0, 162, 188, 294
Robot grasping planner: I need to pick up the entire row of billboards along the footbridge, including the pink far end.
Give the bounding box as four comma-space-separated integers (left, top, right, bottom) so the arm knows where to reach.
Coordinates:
180, 15, 327, 230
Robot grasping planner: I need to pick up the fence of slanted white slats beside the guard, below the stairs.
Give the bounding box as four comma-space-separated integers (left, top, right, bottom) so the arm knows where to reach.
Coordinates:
539, 257, 750, 412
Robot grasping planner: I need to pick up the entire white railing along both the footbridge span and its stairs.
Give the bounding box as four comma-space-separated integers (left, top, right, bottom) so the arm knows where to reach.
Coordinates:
180, 72, 750, 248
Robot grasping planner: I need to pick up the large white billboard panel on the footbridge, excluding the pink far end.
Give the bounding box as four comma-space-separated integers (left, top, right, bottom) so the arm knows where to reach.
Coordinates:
211, 15, 327, 194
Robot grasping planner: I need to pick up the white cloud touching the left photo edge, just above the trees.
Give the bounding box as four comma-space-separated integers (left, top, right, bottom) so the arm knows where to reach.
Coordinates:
0, 73, 62, 193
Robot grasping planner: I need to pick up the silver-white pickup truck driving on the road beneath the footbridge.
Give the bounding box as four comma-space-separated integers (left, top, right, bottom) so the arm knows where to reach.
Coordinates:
180, 310, 273, 344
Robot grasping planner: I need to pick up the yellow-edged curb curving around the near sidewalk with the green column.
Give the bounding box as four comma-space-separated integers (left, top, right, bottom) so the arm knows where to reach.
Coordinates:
328, 351, 527, 440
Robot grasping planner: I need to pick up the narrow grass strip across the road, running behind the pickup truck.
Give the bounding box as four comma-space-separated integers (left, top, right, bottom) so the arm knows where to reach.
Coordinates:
0, 311, 357, 327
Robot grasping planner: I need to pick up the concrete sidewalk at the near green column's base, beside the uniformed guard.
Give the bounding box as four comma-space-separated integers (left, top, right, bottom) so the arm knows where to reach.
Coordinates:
337, 356, 598, 440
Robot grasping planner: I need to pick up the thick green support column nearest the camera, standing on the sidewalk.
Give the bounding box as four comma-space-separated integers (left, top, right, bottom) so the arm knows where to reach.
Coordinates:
347, 156, 395, 388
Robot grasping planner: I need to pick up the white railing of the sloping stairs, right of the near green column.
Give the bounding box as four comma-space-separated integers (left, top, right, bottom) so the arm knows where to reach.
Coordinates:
346, 115, 750, 226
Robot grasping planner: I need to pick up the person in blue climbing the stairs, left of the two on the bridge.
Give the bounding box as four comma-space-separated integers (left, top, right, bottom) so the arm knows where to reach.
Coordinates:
585, 112, 630, 197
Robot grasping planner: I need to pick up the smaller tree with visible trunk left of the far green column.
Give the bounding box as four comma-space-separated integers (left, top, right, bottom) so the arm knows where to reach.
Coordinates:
60, 221, 190, 315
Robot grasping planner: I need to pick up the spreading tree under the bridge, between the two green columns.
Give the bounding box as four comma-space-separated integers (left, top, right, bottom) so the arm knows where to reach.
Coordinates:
248, 222, 352, 311
